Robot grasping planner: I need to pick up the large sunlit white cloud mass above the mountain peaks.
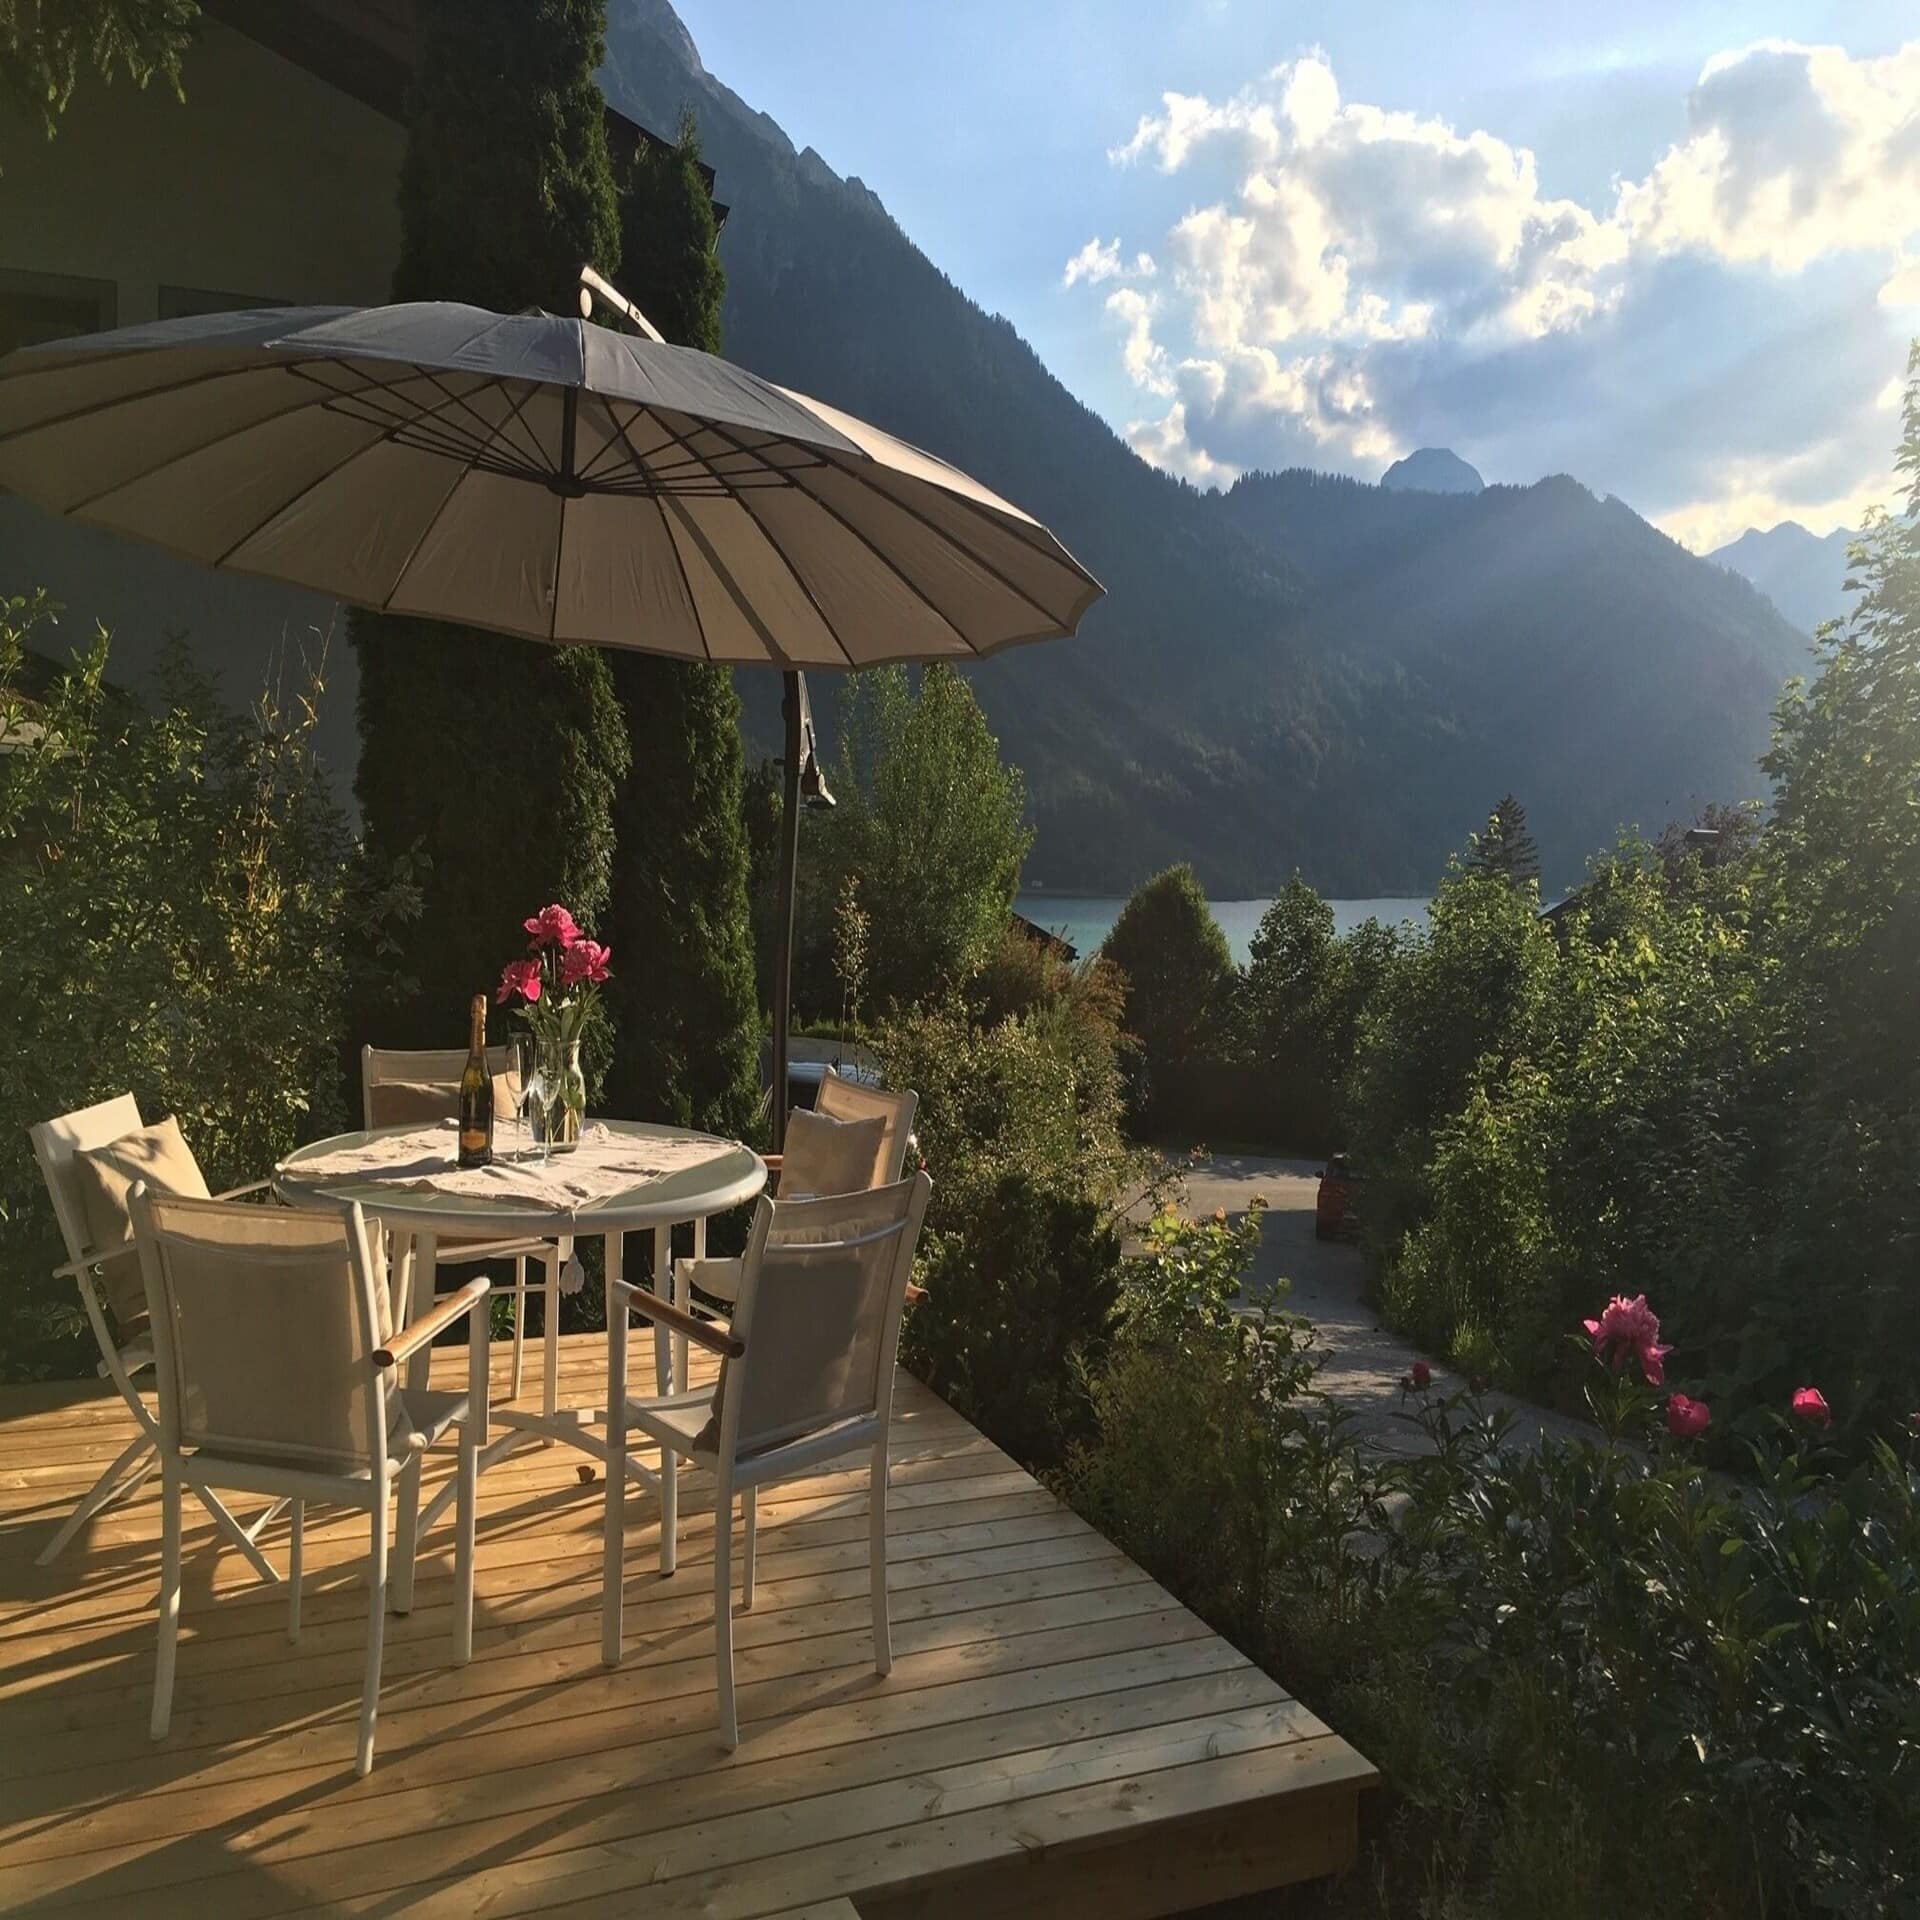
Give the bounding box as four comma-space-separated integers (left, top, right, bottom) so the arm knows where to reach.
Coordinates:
1068, 40, 1920, 522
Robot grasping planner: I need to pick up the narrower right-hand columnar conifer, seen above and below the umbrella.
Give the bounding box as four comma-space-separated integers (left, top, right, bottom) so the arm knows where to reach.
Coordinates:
607, 119, 760, 1135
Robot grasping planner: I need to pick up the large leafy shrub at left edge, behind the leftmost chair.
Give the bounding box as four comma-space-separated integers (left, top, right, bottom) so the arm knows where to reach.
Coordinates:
0, 595, 401, 1379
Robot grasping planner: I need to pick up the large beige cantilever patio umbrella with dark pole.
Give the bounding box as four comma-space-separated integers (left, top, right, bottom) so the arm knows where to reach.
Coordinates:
0, 288, 1102, 1144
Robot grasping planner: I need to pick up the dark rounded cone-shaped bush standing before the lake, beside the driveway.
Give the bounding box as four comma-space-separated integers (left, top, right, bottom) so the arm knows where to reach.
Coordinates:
1100, 866, 1238, 1073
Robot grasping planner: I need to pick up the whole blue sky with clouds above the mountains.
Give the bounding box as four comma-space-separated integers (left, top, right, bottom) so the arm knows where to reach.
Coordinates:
680, 0, 1920, 551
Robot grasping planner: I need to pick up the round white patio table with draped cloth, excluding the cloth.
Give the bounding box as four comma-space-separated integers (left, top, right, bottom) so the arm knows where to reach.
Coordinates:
273, 1119, 766, 1532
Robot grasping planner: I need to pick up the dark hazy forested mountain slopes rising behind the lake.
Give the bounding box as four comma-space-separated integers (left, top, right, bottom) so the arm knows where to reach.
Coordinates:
601, 0, 1805, 897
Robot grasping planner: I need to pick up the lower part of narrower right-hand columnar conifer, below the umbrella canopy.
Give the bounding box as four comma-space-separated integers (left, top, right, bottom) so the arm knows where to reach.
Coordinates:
607, 653, 760, 1137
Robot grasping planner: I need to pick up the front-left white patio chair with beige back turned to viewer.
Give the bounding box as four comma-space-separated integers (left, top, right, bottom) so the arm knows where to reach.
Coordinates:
132, 1185, 488, 1774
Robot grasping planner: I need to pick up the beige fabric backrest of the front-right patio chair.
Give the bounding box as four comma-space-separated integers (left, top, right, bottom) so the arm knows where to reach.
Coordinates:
718, 1173, 933, 1457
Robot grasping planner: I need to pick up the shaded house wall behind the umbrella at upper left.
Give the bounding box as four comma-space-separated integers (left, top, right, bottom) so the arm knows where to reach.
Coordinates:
0, 21, 405, 799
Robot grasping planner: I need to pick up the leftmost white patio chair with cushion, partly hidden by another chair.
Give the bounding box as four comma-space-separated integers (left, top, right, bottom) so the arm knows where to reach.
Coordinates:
29, 1092, 280, 1584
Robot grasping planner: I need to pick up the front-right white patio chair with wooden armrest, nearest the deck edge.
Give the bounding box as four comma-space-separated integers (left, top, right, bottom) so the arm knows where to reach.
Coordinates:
601, 1173, 933, 1747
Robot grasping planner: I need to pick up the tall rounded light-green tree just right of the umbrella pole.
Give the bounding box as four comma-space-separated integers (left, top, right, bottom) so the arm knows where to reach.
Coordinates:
799, 666, 1033, 1012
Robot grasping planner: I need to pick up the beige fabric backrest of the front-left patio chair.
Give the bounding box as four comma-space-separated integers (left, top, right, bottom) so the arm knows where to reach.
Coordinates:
132, 1187, 388, 1476
